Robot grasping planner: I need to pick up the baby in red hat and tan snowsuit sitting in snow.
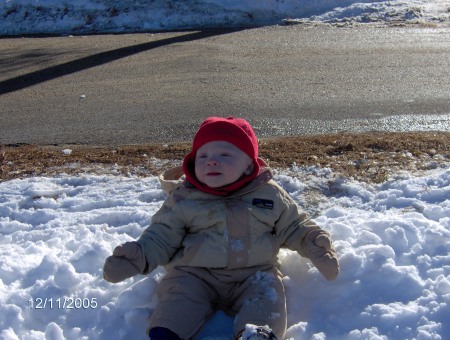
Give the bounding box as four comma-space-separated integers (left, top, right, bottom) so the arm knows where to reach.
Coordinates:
104, 117, 339, 340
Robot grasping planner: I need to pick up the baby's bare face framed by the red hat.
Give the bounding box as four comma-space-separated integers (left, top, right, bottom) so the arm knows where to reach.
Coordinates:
195, 141, 253, 188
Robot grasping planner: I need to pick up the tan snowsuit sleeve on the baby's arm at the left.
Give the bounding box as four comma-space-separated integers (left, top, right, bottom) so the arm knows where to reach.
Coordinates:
137, 191, 186, 274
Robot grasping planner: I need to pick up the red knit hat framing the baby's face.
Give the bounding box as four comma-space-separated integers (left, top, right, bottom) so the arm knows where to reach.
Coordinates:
183, 117, 259, 195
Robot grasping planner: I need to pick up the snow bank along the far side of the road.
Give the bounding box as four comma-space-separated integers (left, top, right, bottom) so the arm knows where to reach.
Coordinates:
0, 0, 450, 35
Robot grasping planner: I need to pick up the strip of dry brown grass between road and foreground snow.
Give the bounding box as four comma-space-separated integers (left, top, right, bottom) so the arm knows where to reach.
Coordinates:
0, 132, 450, 182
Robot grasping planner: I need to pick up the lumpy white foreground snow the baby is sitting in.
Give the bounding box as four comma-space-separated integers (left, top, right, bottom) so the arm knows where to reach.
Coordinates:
0, 166, 450, 339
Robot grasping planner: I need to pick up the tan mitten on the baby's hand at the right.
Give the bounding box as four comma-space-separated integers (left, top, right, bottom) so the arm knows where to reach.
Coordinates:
303, 229, 339, 281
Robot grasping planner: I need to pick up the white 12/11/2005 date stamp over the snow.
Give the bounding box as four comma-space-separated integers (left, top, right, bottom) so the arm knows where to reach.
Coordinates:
28, 297, 98, 309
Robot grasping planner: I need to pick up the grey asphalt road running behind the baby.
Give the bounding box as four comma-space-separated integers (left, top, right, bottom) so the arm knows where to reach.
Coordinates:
0, 26, 450, 145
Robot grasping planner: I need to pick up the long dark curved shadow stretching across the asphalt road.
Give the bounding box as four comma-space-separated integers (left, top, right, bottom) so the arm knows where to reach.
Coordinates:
0, 29, 242, 95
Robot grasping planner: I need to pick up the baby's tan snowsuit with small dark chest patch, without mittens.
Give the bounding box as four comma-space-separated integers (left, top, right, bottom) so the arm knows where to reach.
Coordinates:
137, 163, 328, 339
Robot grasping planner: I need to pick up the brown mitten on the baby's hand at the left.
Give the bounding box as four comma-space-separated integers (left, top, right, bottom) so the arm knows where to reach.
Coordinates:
103, 242, 146, 283
